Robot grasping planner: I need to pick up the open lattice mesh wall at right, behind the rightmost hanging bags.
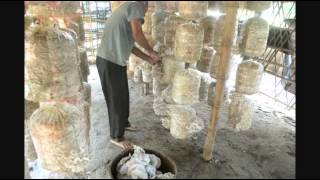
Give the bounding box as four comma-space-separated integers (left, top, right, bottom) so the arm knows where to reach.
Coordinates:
237, 1, 296, 110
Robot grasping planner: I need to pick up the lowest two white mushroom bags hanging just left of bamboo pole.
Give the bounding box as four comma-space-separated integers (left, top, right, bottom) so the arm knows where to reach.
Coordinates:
166, 69, 203, 139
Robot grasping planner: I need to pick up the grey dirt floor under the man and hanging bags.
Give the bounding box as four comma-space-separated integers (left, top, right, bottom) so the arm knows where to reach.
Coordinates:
88, 65, 296, 179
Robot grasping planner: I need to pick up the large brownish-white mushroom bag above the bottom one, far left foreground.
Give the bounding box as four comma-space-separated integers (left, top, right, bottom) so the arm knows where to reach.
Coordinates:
26, 27, 82, 101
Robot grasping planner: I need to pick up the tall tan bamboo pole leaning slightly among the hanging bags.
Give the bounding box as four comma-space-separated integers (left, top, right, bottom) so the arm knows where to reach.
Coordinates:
202, 1, 239, 161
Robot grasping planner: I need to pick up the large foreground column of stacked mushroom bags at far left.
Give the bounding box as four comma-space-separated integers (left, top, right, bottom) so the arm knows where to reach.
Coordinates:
25, 4, 90, 175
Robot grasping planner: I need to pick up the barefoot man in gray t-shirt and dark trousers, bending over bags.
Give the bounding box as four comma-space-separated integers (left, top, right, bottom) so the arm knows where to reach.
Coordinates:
96, 1, 160, 149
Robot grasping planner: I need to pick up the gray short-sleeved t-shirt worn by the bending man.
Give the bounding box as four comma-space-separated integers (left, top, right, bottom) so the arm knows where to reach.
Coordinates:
97, 1, 144, 66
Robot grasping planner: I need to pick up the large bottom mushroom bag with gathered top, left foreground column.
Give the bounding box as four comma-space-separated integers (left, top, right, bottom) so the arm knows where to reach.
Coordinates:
30, 103, 87, 174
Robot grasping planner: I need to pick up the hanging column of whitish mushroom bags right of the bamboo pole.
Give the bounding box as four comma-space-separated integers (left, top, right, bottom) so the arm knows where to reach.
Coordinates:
228, 1, 271, 131
